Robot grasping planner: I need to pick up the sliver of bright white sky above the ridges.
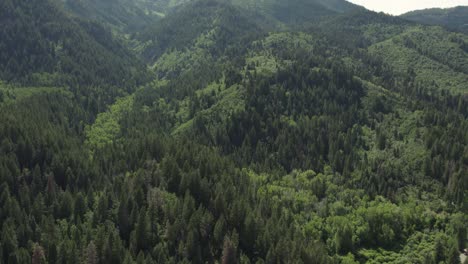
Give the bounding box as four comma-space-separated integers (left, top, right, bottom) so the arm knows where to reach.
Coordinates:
348, 0, 468, 15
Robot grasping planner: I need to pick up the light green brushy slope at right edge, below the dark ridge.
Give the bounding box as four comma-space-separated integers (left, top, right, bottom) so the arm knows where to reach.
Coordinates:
370, 27, 468, 92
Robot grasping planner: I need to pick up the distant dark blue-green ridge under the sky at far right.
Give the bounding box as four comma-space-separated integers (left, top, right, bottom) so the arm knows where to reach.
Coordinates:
401, 6, 468, 33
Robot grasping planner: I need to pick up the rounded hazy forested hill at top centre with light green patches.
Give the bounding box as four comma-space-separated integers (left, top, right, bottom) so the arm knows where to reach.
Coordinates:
138, 0, 268, 86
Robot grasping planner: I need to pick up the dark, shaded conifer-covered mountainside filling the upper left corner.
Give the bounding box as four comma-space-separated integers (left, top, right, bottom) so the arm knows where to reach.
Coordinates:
0, 0, 144, 86
